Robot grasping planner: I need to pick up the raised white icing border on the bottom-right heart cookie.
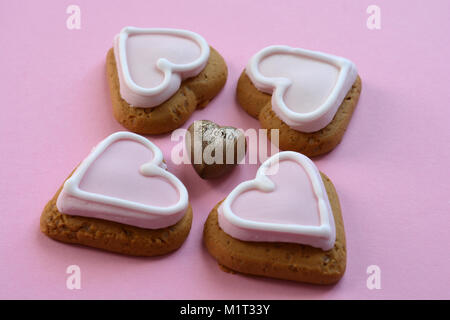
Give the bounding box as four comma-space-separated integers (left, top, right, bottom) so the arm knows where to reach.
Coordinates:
219, 151, 336, 250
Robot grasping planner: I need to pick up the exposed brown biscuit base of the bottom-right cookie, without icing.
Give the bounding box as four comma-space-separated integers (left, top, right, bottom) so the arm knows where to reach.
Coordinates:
203, 174, 347, 284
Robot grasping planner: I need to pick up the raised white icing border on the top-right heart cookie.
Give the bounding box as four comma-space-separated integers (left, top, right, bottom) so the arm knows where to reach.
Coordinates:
246, 45, 358, 132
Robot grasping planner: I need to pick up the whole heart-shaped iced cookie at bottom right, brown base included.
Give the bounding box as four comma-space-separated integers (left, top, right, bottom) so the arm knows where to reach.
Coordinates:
203, 151, 346, 284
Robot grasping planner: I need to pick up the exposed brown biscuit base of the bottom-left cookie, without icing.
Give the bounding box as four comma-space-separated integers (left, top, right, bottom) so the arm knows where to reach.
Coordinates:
40, 184, 192, 257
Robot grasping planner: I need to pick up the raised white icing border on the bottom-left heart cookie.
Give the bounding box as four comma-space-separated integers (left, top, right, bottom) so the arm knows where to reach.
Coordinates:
57, 131, 189, 225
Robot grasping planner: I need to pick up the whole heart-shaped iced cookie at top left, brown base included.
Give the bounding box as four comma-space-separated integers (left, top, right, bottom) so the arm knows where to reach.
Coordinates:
106, 27, 228, 134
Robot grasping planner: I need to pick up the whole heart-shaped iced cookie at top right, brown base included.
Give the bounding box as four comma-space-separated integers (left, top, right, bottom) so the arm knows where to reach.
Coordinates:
237, 46, 361, 157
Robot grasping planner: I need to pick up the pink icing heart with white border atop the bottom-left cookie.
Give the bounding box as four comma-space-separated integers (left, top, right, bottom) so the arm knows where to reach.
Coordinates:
56, 132, 188, 229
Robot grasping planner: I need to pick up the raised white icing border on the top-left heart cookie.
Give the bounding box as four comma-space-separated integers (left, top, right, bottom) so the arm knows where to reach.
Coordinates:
117, 27, 210, 102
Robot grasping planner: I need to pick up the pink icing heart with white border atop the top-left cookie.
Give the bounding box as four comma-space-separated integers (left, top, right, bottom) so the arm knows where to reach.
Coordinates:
114, 27, 210, 107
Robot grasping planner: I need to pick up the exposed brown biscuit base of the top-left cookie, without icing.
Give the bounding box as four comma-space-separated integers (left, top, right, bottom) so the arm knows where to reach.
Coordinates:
106, 47, 228, 134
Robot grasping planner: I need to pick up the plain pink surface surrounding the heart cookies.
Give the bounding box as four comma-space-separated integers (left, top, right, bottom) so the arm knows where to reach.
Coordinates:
0, 0, 450, 299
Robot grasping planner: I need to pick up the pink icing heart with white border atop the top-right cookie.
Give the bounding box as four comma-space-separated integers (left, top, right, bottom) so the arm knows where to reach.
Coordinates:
246, 46, 357, 132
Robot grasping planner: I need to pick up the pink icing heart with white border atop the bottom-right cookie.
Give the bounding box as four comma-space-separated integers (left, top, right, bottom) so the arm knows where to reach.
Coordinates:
218, 151, 336, 250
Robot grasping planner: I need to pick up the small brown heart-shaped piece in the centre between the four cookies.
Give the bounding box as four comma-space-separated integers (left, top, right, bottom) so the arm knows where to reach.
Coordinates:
185, 120, 247, 179
